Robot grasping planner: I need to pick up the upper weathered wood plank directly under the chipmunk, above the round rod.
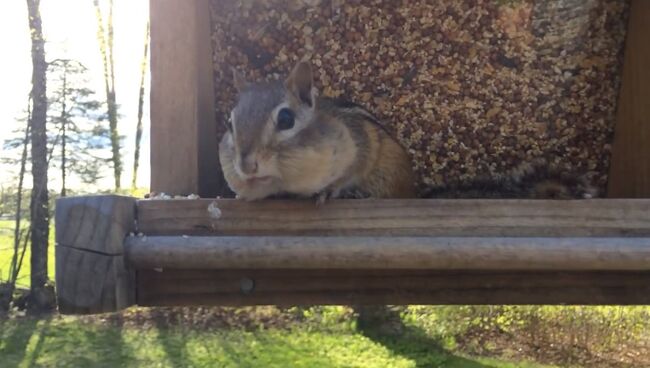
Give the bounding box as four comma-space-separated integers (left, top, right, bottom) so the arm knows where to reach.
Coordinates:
138, 199, 650, 236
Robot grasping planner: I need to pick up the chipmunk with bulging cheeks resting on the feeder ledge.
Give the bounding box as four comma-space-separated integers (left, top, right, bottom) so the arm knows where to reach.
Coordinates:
219, 62, 416, 203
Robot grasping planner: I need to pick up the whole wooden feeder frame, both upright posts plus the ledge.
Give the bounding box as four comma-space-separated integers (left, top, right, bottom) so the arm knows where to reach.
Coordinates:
56, 0, 650, 314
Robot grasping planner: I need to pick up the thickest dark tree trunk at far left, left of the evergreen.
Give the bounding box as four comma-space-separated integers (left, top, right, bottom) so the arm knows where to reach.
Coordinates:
27, 0, 52, 310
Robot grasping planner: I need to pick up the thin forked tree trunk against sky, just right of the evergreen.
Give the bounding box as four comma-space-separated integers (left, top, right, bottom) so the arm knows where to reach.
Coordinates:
93, 0, 122, 190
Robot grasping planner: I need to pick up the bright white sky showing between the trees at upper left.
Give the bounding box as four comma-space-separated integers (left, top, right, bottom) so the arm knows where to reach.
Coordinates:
0, 0, 149, 189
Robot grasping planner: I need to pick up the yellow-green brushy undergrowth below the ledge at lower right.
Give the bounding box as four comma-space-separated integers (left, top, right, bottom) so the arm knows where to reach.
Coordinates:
403, 305, 650, 361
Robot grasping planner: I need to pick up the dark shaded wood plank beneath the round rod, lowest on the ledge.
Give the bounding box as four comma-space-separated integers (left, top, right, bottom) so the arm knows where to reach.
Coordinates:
138, 269, 650, 306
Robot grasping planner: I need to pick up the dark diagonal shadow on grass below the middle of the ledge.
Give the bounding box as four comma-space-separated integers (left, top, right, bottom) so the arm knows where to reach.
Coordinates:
357, 317, 492, 368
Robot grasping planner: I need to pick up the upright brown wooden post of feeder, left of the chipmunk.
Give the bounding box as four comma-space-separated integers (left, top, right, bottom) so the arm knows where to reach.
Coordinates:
150, 0, 225, 197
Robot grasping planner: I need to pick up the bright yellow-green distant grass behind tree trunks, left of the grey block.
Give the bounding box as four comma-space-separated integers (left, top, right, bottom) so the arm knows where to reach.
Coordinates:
0, 220, 54, 287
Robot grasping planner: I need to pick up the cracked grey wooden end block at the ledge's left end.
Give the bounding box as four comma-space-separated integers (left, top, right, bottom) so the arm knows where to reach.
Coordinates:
56, 195, 136, 314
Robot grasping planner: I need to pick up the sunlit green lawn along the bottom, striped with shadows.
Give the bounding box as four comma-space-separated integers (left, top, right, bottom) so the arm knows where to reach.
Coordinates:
0, 317, 556, 368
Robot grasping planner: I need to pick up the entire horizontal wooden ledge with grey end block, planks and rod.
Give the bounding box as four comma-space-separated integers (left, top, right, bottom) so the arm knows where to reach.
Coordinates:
56, 196, 650, 314
